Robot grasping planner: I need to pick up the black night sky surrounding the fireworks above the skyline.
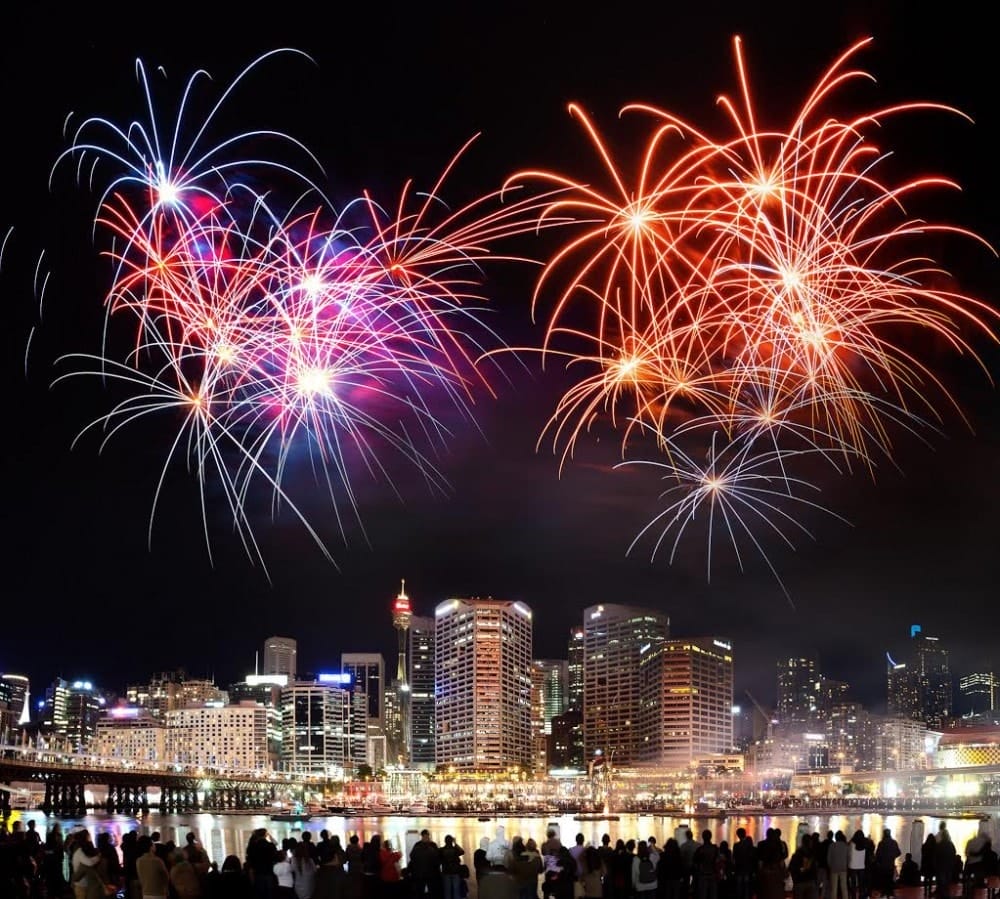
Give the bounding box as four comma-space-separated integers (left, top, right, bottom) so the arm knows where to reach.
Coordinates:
0, 2, 1000, 710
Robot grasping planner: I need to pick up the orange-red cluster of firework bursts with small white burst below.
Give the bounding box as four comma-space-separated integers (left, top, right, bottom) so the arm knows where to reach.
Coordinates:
507, 38, 997, 592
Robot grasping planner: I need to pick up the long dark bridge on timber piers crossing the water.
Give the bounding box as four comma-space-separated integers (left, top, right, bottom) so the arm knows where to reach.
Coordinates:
0, 747, 330, 816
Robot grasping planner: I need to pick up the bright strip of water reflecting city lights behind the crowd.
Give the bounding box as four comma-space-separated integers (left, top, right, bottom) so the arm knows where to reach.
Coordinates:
14, 809, 1000, 865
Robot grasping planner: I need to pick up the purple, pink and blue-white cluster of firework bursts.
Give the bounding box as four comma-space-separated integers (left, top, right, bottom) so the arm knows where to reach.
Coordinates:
43, 50, 554, 568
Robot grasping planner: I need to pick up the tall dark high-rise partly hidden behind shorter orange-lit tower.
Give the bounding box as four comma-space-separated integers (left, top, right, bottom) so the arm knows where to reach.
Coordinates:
582, 604, 668, 766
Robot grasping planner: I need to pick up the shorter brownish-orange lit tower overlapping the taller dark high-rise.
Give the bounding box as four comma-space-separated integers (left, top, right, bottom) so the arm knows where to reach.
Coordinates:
639, 637, 733, 771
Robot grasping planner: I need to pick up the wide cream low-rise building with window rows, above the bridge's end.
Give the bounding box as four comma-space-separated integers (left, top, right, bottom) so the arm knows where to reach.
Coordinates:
164, 702, 268, 771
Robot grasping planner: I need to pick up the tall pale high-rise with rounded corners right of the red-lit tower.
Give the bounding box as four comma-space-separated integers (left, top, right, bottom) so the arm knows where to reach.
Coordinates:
434, 598, 532, 771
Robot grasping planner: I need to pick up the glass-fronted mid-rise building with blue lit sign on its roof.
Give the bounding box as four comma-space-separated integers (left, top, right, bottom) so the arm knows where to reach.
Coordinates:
281, 681, 352, 777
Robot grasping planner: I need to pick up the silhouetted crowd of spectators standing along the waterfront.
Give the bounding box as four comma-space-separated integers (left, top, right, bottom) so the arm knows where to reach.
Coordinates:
0, 821, 1000, 899
